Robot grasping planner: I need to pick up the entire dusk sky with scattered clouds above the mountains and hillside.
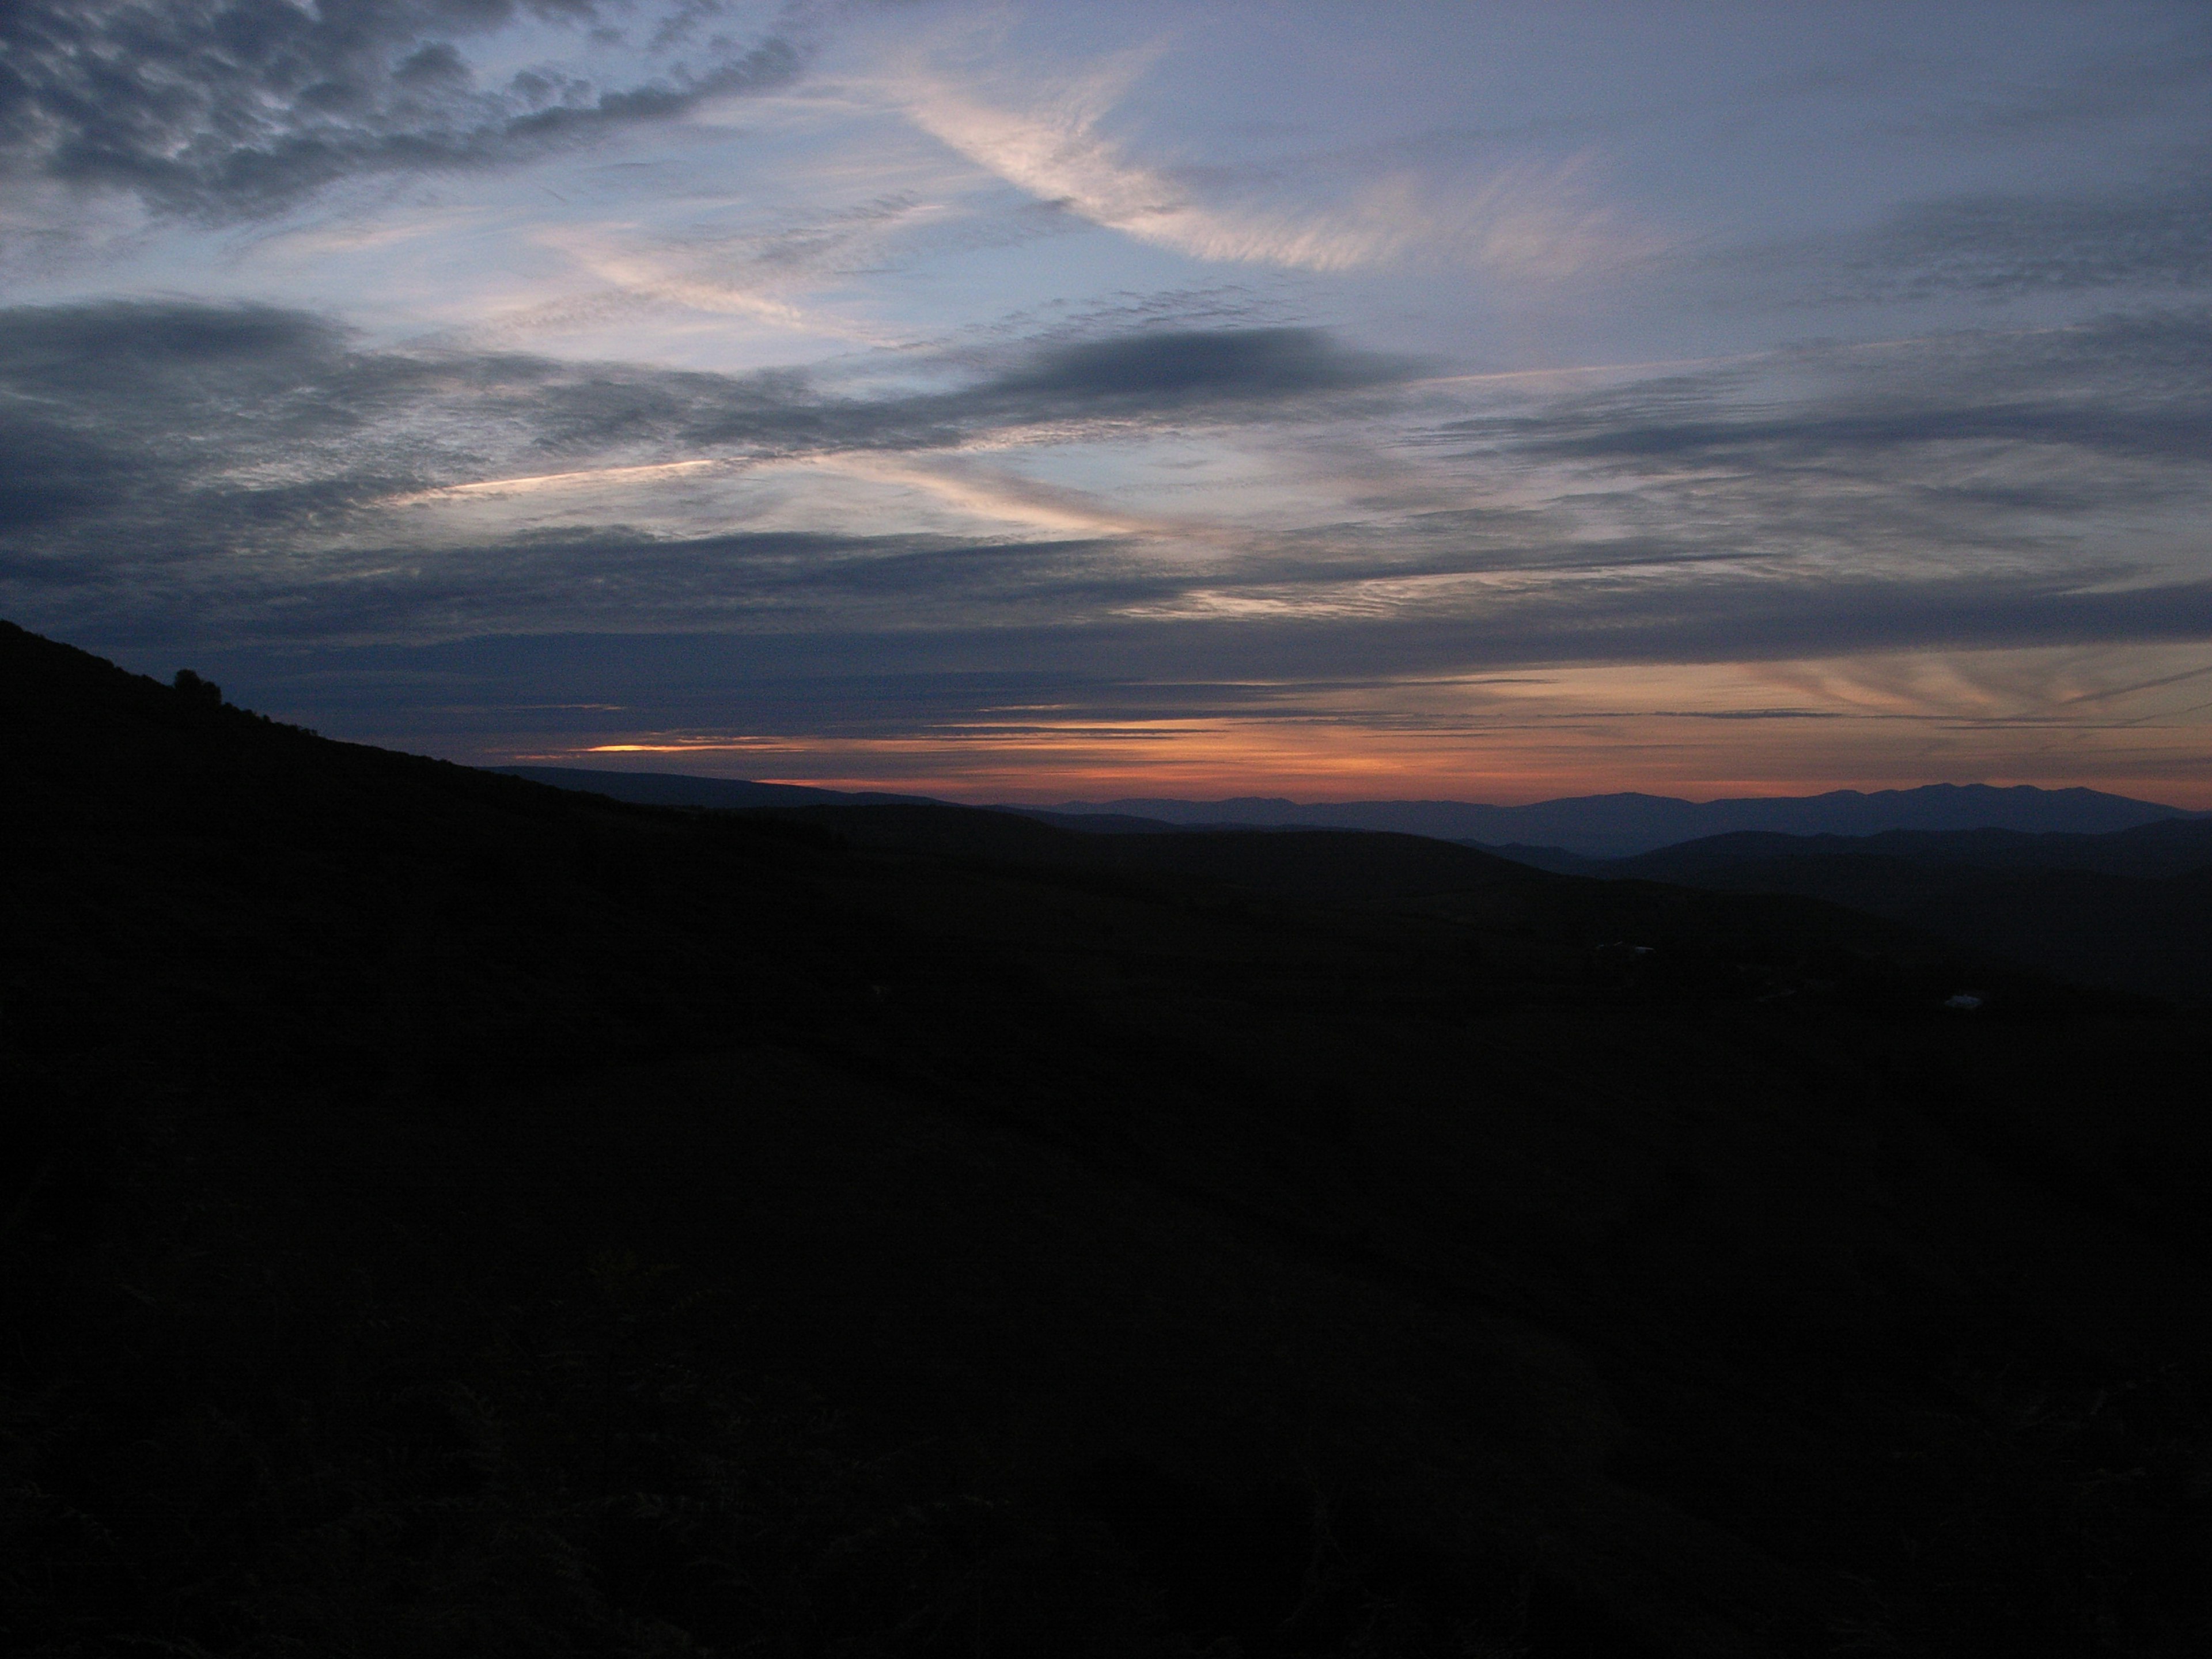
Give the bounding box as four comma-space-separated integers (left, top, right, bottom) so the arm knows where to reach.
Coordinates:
0, 0, 2212, 808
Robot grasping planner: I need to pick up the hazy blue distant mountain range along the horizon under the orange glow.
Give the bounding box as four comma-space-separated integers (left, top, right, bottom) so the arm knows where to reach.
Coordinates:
500, 766, 2212, 874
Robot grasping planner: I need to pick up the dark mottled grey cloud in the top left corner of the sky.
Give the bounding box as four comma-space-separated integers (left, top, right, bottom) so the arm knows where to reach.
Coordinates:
0, 0, 805, 219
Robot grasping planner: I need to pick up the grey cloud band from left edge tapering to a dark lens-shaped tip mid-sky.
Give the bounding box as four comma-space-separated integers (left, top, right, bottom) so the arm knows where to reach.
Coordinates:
0, 303, 1403, 560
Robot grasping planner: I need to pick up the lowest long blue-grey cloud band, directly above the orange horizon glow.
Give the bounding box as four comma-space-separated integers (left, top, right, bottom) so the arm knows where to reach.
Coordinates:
160, 582, 2212, 770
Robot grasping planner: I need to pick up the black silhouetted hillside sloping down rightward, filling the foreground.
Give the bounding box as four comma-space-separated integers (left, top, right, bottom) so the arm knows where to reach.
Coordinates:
0, 630, 2212, 1657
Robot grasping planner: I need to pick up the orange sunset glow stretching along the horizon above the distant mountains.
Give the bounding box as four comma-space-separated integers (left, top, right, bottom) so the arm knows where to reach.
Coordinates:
471, 648, 2212, 809
